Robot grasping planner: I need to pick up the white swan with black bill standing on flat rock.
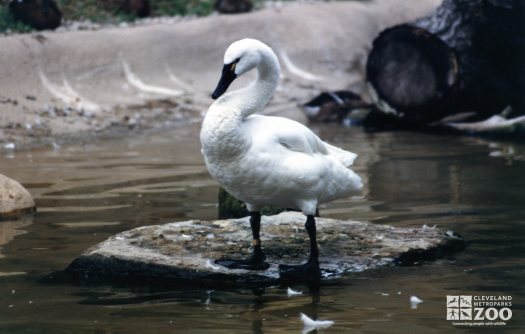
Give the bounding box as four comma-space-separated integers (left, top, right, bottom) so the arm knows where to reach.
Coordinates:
200, 39, 362, 275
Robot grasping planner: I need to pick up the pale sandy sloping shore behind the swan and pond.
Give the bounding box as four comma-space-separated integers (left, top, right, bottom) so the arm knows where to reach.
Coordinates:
0, 0, 440, 151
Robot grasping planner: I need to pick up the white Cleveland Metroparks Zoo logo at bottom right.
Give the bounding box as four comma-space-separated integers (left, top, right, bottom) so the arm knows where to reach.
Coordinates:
446, 295, 512, 325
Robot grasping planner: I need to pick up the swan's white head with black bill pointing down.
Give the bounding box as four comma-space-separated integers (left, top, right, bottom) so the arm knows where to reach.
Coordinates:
211, 38, 274, 99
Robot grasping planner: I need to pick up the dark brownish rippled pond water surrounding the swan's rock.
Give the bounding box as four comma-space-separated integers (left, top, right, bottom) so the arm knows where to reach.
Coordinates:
0, 125, 525, 333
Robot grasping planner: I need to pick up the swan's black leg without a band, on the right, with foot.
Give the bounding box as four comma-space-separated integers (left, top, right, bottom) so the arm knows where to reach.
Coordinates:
279, 215, 321, 281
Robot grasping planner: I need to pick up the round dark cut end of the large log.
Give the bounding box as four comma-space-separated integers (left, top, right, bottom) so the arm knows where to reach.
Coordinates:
367, 25, 459, 117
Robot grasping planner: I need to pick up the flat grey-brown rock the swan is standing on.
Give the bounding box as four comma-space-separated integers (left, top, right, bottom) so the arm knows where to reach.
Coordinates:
66, 212, 464, 287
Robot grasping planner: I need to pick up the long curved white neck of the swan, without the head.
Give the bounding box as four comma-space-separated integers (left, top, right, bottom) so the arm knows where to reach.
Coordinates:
201, 50, 280, 160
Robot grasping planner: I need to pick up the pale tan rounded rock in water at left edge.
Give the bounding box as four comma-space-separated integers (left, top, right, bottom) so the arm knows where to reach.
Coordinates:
0, 174, 36, 220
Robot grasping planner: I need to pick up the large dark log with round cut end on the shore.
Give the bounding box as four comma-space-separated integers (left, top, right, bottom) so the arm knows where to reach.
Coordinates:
365, 0, 525, 126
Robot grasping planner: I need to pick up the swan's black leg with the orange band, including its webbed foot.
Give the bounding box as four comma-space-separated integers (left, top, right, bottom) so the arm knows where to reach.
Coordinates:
215, 211, 270, 270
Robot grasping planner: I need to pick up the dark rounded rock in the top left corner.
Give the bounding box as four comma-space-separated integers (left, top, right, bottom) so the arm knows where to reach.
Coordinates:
9, 0, 62, 30
